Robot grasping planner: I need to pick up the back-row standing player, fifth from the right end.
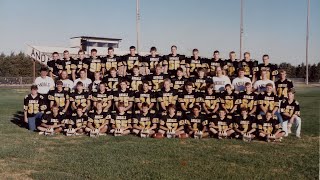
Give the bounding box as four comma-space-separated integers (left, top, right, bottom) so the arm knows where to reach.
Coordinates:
186, 49, 208, 77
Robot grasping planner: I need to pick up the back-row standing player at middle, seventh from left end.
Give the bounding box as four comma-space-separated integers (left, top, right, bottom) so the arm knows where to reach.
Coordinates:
143, 47, 163, 74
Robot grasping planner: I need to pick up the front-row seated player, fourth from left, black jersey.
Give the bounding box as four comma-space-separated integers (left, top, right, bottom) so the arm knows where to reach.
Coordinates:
110, 103, 132, 136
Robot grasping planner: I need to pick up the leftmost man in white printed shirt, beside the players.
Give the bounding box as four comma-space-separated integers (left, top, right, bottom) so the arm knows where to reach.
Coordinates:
34, 67, 55, 95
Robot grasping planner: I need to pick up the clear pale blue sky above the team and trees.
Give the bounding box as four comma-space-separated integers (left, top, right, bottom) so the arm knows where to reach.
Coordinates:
0, 0, 320, 64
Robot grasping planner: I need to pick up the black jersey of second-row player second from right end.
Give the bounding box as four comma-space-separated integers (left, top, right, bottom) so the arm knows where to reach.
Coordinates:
258, 92, 279, 111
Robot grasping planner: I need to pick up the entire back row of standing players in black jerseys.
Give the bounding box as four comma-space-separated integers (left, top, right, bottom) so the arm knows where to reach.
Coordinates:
47, 46, 278, 82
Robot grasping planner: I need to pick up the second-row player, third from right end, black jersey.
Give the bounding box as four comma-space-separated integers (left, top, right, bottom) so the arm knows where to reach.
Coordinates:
238, 82, 258, 116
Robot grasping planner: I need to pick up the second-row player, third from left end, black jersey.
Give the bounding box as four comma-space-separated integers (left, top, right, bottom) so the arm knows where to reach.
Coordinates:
70, 82, 90, 112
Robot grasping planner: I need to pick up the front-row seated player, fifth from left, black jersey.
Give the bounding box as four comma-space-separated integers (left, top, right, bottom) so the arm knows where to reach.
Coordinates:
132, 102, 159, 137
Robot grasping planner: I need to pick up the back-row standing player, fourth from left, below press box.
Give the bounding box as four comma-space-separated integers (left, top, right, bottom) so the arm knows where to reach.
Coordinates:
85, 49, 104, 80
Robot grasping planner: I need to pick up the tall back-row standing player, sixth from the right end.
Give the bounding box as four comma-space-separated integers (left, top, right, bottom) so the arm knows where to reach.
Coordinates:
163, 45, 185, 76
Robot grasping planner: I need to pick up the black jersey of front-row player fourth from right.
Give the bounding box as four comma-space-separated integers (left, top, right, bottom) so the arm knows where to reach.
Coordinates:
185, 113, 209, 131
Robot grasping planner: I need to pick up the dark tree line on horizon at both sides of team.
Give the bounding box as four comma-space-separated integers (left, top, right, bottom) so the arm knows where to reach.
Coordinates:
0, 52, 320, 82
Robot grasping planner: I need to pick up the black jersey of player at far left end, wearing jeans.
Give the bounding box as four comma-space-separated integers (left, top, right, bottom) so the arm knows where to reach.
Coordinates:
23, 94, 47, 117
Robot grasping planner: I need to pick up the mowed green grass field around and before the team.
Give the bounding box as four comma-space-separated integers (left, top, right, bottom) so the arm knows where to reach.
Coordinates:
0, 88, 320, 179
